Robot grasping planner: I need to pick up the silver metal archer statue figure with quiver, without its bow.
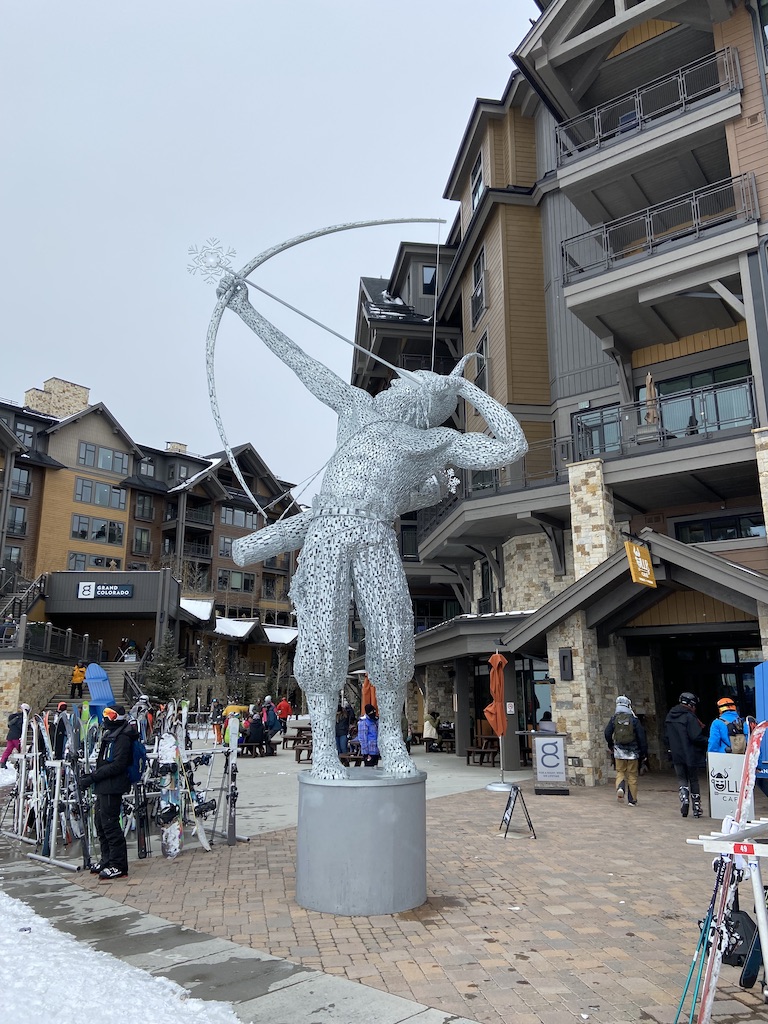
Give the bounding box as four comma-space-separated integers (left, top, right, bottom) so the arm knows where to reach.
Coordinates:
218, 274, 527, 779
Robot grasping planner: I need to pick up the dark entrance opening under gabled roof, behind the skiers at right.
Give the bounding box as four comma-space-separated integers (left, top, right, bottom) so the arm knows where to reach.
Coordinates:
662, 633, 763, 725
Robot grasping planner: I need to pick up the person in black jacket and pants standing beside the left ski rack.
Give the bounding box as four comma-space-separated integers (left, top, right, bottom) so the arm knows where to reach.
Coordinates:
80, 705, 137, 881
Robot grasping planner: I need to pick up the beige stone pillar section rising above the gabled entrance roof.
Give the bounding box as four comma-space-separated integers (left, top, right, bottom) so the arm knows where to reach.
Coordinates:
568, 459, 621, 580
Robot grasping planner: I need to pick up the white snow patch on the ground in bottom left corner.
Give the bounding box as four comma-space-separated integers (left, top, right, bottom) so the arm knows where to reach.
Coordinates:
0, 880, 240, 1024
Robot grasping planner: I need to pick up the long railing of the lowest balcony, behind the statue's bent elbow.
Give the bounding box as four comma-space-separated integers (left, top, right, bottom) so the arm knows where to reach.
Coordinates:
417, 377, 758, 542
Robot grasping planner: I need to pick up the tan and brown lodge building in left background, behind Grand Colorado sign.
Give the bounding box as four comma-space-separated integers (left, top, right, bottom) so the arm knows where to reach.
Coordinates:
0, 378, 298, 674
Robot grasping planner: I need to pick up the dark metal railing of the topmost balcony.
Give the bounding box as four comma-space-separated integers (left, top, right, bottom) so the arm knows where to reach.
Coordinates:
556, 47, 741, 167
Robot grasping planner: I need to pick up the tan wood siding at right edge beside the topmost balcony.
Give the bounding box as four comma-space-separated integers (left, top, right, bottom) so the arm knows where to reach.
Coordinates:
714, 6, 768, 215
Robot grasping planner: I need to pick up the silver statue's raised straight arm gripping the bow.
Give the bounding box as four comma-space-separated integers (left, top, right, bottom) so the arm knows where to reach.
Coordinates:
218, 274, 355, 413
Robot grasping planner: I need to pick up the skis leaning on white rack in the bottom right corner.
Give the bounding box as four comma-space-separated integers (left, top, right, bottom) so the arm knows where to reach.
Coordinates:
674, 722, 768, 1024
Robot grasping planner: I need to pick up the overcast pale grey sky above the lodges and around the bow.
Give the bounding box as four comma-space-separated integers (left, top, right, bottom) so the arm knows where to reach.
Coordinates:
0, 0, 538, 500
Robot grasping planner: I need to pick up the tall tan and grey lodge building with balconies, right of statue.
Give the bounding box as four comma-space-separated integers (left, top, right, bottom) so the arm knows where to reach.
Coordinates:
353, 0, 768, 784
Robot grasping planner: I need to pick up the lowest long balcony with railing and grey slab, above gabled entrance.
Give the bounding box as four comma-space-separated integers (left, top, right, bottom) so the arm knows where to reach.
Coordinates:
417, 377, 759, 562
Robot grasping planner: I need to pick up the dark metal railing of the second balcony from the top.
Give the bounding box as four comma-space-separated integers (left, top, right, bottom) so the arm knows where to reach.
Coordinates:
562, 172, 759, 285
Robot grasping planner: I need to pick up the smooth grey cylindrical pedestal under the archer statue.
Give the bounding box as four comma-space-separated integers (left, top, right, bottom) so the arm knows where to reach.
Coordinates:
296, 768, 427, 916
